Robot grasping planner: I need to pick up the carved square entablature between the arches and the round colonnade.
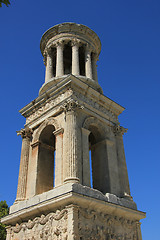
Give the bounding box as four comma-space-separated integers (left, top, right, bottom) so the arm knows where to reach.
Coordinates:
20, 75, 124, 126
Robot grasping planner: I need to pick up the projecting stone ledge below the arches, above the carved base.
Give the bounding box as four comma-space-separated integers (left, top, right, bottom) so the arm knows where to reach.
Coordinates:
1, 183, 145, 225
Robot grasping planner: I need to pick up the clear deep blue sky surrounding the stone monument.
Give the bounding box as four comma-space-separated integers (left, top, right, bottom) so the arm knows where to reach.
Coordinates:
0, 0, 160, 240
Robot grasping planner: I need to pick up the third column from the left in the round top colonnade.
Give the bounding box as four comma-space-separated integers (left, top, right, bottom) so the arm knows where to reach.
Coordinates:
72, 40, 79, 75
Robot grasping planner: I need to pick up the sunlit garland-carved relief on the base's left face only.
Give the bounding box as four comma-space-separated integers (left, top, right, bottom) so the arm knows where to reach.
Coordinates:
7, 209, 68, 240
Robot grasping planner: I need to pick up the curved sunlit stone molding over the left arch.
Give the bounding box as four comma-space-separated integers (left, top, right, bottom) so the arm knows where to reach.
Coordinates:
33, 117, 61, 143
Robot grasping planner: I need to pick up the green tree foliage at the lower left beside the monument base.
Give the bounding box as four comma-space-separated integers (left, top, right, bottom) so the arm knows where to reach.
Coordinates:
0, 201, 9, 240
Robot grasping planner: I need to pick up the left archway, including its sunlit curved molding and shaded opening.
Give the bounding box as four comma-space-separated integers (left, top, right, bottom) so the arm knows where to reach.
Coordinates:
32, 118, 60, 194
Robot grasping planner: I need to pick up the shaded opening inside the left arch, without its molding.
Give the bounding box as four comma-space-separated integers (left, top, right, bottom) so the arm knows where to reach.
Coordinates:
36, 125, 56, 194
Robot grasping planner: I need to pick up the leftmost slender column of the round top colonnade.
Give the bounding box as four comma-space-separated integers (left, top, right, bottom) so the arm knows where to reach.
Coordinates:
45, 49, 53, 83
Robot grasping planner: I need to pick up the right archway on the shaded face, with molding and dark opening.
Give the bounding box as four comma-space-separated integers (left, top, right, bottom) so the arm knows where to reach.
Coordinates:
83, 117, 110, 194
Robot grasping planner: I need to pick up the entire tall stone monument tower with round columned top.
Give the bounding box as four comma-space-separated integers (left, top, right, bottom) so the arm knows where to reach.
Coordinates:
2, 23, 145, 240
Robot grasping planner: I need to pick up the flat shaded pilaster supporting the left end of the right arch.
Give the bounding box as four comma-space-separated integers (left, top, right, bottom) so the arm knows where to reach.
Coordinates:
82, 128, 91, 187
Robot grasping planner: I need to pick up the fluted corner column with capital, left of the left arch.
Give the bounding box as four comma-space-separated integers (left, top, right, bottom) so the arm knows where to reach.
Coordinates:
16, 128, 32, 201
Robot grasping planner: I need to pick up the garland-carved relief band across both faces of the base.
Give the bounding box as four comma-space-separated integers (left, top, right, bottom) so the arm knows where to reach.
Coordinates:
7, 207, 140, 240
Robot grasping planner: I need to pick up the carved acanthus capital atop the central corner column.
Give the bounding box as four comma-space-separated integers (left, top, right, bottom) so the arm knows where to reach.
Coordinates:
61, 99, 84, 113
